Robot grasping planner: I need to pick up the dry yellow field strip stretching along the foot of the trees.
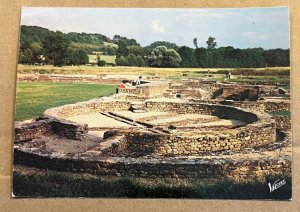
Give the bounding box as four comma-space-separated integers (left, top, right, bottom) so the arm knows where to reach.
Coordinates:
18, 64, 290, 86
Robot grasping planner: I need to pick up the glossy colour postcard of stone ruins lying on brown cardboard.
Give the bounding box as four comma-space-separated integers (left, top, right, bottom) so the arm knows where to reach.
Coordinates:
13, 7, 292, 200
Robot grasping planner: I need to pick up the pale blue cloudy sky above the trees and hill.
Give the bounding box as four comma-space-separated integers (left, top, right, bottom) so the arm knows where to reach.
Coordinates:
21, 7, 290, 49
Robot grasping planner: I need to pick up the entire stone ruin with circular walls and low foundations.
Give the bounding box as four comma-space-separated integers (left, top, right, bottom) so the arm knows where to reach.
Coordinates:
14, 80, 291, 180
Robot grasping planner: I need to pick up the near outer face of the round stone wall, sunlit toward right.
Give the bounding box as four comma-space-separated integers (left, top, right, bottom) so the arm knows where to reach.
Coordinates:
104, 123, 276, 157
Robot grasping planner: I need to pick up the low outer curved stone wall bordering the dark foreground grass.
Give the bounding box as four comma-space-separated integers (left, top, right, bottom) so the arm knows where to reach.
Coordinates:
14, 149, 291, 180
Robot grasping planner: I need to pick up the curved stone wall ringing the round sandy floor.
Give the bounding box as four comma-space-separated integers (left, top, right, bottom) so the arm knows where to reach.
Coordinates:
40, 99, 276, 155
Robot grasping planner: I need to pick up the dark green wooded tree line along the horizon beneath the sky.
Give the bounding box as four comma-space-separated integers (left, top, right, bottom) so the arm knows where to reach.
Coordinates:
19, 26, 290, 68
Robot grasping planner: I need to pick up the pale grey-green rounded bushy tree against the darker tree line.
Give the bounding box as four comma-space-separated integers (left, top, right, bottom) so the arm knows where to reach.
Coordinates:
147, 46, 181, 67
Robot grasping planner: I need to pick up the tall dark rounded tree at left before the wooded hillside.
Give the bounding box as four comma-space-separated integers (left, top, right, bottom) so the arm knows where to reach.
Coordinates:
43, 32, 70, 66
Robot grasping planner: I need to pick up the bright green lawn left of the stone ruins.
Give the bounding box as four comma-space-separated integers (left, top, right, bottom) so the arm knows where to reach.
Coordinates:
15, 83, 116, 121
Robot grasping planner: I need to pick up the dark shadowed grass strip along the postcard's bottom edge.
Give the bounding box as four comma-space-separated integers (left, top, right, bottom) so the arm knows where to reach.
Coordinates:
13, 170, 292, 199
